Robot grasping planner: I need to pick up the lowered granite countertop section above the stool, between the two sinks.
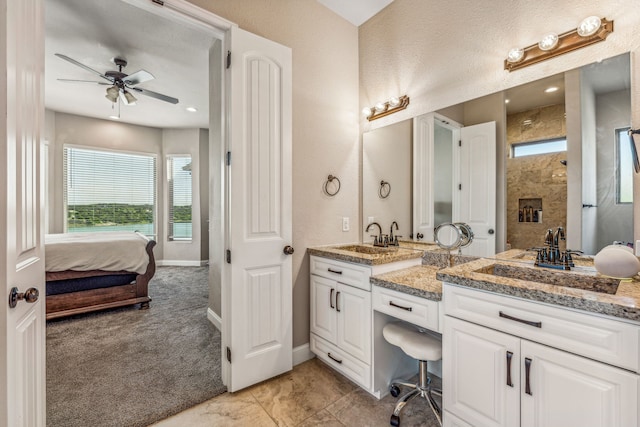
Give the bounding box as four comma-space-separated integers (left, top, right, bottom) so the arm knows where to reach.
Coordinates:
369, 265, 442, 301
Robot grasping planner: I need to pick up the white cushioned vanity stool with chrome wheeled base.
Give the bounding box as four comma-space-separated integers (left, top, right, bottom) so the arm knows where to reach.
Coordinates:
382, 322, 442, 426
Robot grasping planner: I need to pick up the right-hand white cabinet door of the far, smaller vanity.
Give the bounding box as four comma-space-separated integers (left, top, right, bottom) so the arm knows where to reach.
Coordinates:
336, 283, 372, 364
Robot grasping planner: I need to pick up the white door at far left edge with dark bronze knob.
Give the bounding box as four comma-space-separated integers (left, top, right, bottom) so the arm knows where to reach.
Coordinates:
0, 0, 46, 427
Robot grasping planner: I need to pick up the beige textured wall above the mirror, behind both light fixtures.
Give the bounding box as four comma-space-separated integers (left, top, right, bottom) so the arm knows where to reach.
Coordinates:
359, 0, 640, 254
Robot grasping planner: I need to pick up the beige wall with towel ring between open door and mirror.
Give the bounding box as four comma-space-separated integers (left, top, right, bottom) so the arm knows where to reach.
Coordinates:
190, 0, 360, 346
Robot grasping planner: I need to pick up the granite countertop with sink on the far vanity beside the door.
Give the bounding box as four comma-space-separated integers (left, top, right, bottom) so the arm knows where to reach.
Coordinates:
307, 243, 423, 265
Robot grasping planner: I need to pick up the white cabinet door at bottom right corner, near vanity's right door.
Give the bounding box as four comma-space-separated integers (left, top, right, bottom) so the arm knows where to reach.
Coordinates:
520, 340, 640, 427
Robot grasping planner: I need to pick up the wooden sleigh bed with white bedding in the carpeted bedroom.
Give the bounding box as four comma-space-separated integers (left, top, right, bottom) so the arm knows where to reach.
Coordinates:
45, 232, 156, 319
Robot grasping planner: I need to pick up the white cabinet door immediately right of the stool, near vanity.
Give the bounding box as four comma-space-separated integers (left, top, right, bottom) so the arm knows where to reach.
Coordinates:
442, 316, 520, 427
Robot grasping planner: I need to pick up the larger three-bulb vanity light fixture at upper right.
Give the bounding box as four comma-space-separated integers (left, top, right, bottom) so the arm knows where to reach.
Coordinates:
504, 16, 613, 71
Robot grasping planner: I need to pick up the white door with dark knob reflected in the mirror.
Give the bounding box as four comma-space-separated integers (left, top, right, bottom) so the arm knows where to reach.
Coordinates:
454, 122, 496, 256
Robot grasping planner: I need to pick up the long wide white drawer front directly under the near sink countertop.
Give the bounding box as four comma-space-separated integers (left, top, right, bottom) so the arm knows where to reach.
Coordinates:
443, 283, 640, 372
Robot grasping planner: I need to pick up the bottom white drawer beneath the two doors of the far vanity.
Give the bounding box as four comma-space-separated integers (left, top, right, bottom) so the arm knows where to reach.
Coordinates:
309, 334, 371, 390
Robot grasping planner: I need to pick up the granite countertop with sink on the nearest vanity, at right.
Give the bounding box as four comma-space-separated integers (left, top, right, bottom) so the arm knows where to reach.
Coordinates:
436, 250, 640, 321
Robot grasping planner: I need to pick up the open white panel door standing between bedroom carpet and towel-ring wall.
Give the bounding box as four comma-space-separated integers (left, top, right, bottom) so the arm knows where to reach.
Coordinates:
222, 27, 293, 391
